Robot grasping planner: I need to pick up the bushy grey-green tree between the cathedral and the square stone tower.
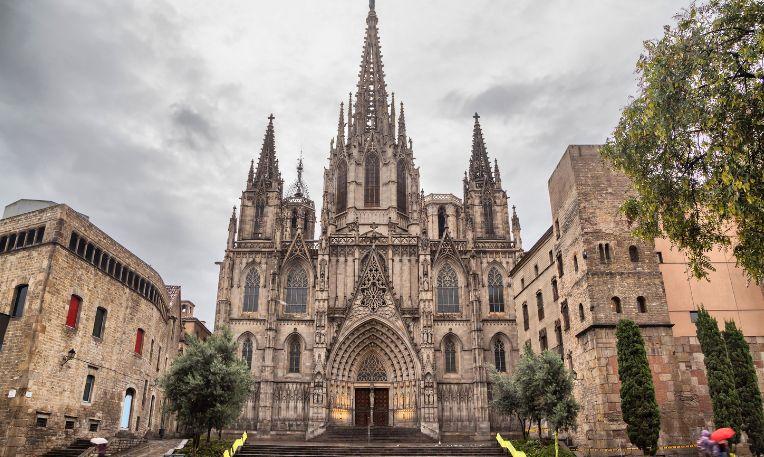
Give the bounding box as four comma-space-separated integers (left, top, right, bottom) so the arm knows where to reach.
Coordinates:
491, 346, 579, 439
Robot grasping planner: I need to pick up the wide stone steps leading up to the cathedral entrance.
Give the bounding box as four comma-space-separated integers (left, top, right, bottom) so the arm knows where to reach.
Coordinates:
236, 427, 506, 457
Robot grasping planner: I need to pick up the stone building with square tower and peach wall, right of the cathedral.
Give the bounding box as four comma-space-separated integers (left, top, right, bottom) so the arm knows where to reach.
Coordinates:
510, 145, 764, 449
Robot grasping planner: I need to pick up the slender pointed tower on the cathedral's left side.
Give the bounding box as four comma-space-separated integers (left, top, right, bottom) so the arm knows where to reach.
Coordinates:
238, 114, 284, 240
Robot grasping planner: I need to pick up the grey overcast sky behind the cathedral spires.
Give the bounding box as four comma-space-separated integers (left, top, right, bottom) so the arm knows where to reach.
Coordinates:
0, 0, 688, 324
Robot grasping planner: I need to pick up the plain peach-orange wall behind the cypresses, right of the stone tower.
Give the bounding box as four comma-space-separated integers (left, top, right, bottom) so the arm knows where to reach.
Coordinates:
655, 238, 764, 336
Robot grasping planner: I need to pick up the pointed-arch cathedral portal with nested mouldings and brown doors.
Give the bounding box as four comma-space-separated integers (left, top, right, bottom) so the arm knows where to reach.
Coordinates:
326, 318, 420, 427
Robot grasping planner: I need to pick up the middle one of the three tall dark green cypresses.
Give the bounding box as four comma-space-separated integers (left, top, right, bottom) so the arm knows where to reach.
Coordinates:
695, 308, 741, 442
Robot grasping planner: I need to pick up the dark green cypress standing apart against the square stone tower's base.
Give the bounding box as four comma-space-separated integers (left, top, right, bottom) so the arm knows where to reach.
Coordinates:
616, 319, 661, 455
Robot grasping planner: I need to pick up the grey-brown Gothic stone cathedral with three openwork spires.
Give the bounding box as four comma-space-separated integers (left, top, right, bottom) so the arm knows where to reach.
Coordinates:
215, 0, 522, 438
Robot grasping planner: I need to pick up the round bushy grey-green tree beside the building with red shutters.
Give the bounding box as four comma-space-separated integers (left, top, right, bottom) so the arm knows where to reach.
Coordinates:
161, 328, 252, 447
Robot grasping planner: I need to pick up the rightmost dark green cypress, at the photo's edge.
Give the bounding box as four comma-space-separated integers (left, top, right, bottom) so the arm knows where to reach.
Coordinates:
722, 321, 764, 455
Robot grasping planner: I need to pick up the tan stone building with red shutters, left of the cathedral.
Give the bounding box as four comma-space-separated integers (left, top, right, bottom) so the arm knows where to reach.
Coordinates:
0, 200, 181, 456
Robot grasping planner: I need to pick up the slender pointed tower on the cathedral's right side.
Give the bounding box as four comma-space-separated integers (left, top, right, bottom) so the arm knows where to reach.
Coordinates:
464, 113, 511, 240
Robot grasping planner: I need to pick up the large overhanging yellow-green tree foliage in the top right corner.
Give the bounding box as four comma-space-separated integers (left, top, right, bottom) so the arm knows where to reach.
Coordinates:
602, 0, 764, 281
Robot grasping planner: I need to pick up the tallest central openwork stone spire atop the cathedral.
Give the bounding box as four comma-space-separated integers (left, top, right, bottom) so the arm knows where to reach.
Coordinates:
353, 1, 389, 134
